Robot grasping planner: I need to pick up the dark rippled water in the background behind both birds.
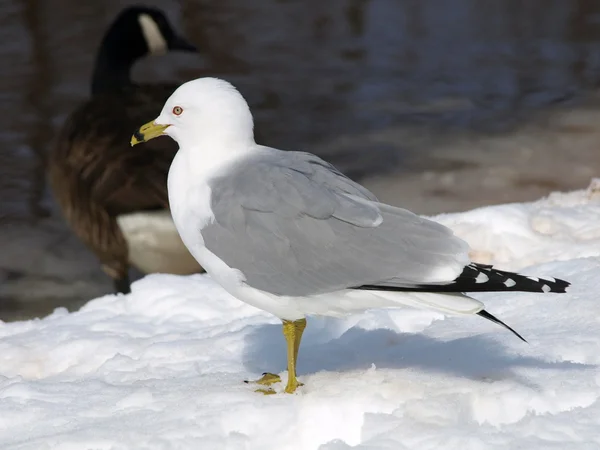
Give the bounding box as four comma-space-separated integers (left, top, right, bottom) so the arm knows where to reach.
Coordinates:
0, 0, 600, 316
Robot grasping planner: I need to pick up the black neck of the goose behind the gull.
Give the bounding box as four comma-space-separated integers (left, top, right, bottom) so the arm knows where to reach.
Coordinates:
92, 32, 147, 95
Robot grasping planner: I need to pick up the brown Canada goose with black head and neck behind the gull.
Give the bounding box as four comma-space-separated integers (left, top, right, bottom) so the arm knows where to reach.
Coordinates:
48, 6, 202, 293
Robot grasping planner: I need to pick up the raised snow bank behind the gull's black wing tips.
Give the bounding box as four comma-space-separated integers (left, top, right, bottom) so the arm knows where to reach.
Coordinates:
434, 179, 600, 270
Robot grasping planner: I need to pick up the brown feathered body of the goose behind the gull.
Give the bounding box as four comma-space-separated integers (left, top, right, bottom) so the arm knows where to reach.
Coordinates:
48, 10, 202, 293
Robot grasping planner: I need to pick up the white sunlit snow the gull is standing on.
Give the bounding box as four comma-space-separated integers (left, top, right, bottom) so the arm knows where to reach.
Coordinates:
0, 183, 600, 450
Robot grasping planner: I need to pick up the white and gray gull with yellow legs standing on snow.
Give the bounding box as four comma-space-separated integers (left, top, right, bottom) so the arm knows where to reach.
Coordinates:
131, 78, 570, 394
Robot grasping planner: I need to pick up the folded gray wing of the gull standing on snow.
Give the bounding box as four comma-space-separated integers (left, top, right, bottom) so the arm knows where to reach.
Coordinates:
201, 149, 469, 296
